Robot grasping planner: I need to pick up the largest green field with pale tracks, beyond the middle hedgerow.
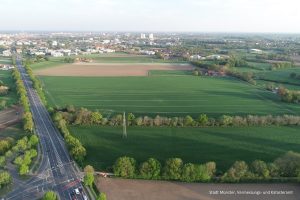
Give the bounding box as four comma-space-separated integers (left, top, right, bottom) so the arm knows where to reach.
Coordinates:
41, 76, 300, 117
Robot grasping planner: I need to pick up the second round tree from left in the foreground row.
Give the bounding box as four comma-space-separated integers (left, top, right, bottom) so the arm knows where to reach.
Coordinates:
140, 158, 161, 179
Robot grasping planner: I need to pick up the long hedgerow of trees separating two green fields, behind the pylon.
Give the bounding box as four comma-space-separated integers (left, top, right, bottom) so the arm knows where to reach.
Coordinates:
54, 106, 300, 127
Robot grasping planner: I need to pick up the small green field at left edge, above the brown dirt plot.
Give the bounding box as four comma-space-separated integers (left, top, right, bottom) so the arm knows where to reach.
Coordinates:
0, 71, 18, 109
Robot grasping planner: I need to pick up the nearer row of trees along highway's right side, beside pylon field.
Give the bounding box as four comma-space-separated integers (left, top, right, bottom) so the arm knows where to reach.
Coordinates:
53, 112, 86, 163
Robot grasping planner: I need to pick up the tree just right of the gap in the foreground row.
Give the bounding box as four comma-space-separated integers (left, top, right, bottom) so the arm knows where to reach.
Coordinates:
222, 161, 248, 182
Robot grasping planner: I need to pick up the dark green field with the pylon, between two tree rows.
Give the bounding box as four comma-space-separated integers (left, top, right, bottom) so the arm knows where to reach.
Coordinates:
70, 126, 300, 170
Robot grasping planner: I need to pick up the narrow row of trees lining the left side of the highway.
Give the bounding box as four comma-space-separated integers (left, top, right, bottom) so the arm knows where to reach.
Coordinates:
12, 69, 34, 132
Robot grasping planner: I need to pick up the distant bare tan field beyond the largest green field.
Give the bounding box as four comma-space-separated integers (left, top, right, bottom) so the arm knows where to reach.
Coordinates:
35, 63, 194, 77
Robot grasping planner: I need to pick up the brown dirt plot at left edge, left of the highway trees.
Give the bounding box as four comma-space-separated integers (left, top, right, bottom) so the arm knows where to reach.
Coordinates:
0, 106, 22, 131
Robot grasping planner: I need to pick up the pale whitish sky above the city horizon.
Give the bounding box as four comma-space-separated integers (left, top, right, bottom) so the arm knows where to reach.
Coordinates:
0, 0, 300, 33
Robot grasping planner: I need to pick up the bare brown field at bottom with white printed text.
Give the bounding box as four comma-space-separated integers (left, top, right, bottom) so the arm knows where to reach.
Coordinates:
97, 177, 300, 200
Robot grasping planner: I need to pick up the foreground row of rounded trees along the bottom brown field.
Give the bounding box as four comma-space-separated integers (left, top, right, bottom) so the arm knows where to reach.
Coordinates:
113, 151, 300, 182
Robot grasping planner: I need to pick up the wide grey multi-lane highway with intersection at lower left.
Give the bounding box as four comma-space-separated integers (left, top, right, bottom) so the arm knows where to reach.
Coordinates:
4, 57, 85, 200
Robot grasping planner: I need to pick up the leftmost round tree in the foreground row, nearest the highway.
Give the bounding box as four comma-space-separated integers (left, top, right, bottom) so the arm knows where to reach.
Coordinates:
113, 156, 136, 178
